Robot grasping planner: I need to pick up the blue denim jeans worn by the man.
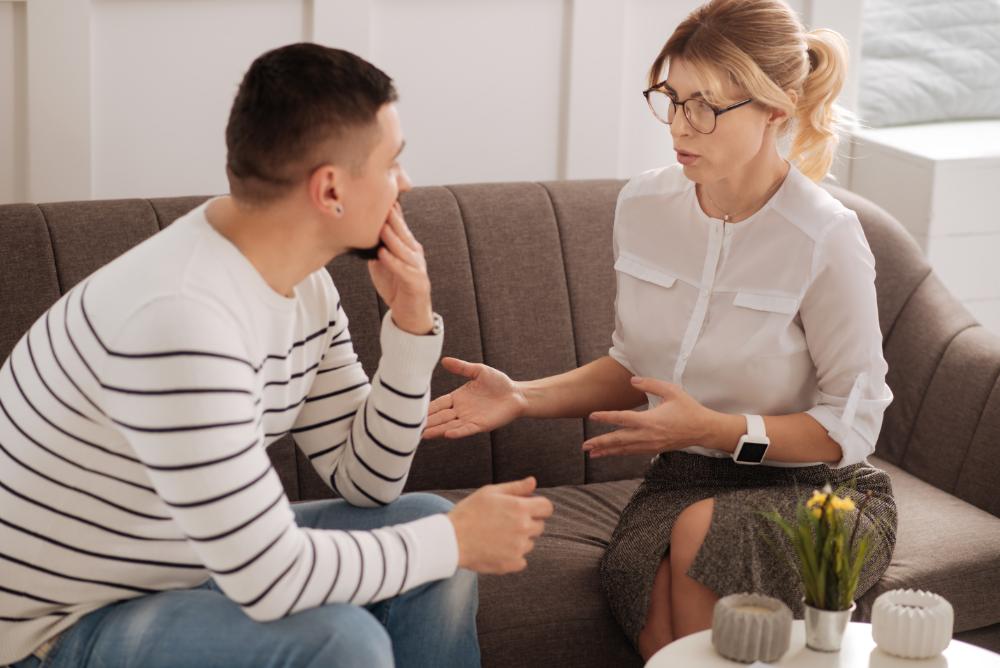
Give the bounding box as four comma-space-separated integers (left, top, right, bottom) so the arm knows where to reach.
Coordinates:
14, 493, 479, 668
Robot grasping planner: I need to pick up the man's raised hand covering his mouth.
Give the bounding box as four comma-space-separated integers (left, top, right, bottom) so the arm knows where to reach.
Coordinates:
368, 202, 434, 334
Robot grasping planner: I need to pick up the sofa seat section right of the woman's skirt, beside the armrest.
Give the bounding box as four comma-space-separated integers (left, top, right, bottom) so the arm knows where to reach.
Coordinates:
858, 457, 1000, 632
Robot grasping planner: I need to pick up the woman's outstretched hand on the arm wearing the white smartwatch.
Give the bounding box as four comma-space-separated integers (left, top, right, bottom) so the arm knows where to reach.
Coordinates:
583, 377, 718, 457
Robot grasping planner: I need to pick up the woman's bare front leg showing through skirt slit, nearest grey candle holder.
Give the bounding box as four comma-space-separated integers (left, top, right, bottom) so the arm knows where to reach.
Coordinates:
670, 498, 719, 639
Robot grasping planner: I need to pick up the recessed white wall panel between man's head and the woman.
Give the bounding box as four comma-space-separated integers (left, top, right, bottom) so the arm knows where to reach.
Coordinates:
371, 0, 566, 184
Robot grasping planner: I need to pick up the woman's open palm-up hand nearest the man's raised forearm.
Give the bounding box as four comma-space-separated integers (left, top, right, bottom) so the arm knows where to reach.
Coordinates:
423, 357, 525, 439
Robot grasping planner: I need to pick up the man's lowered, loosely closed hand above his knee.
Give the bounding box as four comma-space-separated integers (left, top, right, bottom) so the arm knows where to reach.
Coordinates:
448, 477, 553, 574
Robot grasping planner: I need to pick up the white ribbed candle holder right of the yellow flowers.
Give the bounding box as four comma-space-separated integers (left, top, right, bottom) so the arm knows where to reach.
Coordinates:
872, 589, 955, 659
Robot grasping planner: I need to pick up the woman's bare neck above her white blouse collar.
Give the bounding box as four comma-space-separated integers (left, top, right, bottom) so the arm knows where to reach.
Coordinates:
696, 151, 791, 223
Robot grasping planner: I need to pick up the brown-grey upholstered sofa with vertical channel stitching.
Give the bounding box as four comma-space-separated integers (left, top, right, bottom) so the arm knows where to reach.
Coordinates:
0, 181, 1000, 666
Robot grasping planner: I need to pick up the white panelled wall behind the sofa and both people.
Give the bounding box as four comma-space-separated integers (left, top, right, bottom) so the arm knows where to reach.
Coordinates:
0, 0, 861, 202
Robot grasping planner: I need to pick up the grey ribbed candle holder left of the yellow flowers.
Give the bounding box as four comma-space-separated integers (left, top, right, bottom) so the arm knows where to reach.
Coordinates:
712, 594, 792, 663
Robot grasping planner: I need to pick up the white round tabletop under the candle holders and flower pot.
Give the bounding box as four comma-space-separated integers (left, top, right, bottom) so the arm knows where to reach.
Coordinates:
646, 619, 1000, 668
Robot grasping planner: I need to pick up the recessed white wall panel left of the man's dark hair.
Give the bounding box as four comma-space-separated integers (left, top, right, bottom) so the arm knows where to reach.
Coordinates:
93, 0, 305, 198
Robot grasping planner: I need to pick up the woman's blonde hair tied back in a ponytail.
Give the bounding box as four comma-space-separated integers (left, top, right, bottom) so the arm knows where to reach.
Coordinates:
649, 0, 850, 181
